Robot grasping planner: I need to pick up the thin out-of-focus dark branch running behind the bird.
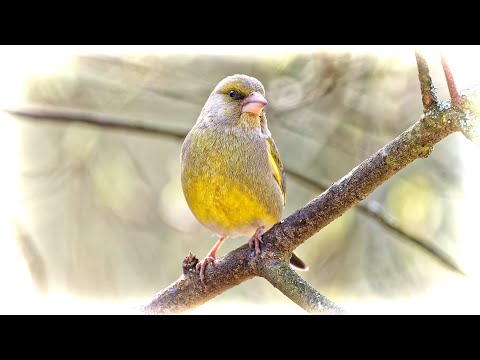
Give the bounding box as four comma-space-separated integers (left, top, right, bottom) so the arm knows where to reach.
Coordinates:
3, 107, 463, 274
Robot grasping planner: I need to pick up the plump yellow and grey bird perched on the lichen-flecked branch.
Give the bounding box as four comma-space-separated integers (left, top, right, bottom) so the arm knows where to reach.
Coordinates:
181, 74, 307, 282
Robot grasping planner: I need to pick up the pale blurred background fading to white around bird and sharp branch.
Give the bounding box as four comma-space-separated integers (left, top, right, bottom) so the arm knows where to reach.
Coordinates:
0, 46, 480, 314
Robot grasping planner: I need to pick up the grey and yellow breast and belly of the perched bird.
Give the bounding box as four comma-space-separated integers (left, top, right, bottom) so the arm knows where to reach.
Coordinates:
182, 128, 283, 236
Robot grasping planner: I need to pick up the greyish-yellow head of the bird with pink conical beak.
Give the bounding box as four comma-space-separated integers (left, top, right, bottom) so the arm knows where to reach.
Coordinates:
198, 74, 267, 124
